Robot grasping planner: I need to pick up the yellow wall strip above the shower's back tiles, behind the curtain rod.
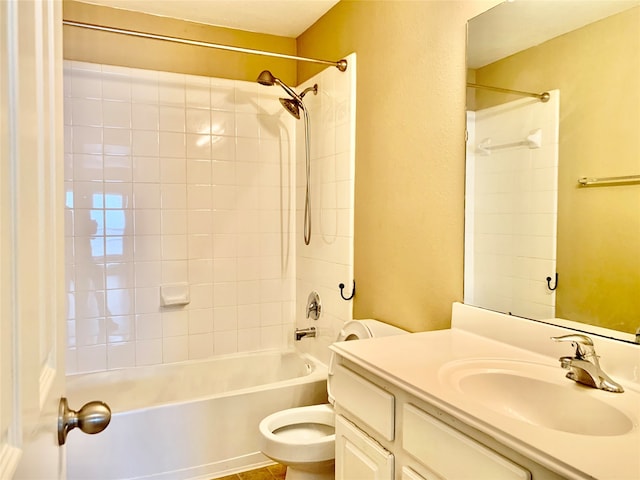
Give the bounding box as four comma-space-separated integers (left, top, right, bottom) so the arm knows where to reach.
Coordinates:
63, 0, 297, 85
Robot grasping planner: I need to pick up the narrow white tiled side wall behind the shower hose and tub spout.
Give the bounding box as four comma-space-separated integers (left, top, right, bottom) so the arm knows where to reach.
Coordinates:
295, 54, 356, 362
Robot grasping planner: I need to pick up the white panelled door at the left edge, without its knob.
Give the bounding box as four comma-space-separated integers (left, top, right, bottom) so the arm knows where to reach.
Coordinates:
0, 0, 65, 479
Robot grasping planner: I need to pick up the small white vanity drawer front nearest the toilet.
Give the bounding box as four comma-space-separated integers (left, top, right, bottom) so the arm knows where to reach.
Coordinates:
329, 364, 395, 441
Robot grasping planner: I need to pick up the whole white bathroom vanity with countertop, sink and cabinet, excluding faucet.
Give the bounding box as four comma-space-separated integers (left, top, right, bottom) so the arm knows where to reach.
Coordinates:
330, 303, 640, 480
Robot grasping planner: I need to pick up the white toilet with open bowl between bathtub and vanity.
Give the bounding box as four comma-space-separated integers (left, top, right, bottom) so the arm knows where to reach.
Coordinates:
259, 320, 407, 480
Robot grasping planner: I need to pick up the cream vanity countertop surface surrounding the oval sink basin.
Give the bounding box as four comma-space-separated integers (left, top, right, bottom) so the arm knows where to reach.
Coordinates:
331, 328, 640, 480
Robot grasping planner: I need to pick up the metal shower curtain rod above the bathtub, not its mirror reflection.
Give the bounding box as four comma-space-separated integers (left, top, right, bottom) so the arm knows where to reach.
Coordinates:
62, 20, 347, 72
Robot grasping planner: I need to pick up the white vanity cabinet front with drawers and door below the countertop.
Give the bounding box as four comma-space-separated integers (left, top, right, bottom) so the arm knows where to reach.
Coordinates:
331, 357, 562, 480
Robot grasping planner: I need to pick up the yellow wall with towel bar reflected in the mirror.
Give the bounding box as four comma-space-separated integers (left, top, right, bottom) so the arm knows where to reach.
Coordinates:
475, 7, 640, 333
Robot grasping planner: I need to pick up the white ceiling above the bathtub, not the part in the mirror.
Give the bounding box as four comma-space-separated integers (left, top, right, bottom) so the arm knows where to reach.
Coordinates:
81, 0, 339, 38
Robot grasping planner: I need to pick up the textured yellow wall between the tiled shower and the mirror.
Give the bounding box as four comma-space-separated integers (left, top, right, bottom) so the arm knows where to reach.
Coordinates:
298, 0, 499, 331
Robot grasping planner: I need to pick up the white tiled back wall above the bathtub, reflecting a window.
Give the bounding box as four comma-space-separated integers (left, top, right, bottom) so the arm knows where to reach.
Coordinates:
65, 57, 353, 373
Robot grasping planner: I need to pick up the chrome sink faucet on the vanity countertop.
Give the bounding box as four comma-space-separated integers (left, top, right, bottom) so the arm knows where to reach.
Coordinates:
551, 334, 624, 393
